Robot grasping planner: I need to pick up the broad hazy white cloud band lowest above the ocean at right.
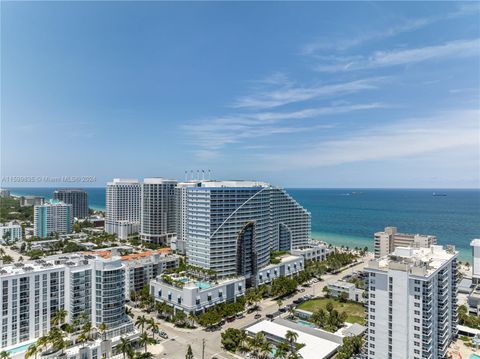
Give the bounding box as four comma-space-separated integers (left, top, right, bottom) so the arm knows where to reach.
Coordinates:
263, 110, 480, 170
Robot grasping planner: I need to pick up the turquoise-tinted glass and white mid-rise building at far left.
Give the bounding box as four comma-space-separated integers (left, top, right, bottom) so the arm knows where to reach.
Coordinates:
33, 200, 73, 238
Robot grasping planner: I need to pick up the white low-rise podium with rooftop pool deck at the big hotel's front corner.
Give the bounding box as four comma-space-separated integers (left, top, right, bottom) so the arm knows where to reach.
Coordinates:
150, 274, 245, 314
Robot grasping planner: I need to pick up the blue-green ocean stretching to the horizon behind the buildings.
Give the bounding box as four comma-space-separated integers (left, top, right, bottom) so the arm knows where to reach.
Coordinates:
5, 188, 480, 261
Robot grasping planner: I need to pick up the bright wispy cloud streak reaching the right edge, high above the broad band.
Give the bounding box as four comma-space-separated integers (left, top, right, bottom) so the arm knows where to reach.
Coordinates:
316, 39, 480, 72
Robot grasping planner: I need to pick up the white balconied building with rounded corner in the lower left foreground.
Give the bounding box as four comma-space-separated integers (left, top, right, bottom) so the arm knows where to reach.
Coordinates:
0, 254, 134, 352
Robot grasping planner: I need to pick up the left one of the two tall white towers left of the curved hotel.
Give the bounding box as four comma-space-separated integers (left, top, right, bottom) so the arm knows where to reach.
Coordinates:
105, 178, 140, 239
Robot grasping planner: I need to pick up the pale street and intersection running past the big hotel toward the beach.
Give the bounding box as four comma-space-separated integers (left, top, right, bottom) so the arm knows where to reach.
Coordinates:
133, 260, 372, 359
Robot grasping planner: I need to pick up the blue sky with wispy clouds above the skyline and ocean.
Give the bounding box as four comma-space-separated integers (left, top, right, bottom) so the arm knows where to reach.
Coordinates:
1, 2, 480, 188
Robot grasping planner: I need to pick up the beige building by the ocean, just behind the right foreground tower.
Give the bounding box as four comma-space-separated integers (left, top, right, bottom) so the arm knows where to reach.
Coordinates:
374, 227, 437, 258
